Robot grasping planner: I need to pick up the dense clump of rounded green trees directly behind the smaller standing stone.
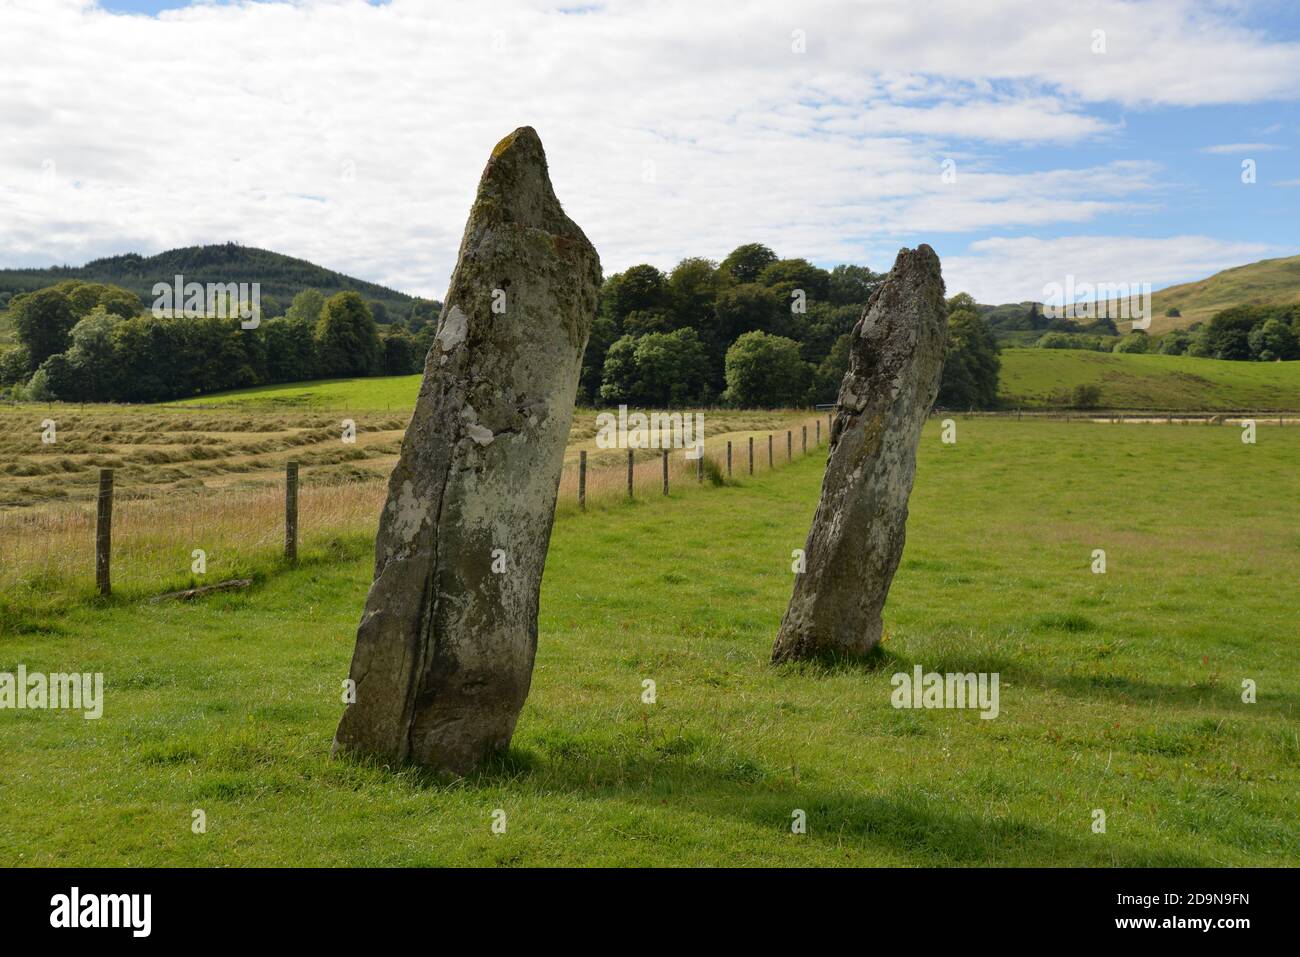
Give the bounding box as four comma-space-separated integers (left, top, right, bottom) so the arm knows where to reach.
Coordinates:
579, 243, 1000, 408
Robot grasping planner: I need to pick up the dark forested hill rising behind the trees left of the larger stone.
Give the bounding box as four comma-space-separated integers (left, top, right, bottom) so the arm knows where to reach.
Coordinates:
0, 243, 413, 319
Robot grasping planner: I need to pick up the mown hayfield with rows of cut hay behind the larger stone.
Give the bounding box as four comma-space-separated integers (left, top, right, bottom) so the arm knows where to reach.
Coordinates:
0, 400, 824, 514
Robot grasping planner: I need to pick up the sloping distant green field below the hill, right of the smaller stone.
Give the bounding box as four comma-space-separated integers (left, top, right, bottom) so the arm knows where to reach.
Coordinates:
1000, 348, 1300, 412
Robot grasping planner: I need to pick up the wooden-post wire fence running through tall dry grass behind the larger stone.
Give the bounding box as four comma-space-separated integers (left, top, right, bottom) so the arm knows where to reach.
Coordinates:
0, 415, 831, 597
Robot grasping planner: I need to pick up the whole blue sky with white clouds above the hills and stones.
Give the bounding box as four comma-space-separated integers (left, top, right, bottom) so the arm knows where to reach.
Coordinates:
0, 0, 1300, 302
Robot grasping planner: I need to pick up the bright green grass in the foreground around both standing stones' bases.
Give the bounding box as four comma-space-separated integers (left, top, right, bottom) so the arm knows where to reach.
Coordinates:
0, 419, 1300, 866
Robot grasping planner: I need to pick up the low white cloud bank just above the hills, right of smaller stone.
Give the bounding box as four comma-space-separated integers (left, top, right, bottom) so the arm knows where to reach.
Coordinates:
944, 235, 1297, 303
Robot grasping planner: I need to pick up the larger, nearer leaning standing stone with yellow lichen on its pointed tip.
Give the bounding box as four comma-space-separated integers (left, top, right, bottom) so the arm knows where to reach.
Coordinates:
334, 127, 601, 774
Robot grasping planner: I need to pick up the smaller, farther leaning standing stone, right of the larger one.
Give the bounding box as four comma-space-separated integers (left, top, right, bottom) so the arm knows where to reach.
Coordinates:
772, 246, 948, 662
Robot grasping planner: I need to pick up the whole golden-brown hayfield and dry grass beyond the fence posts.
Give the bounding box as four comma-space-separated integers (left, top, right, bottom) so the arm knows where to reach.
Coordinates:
0, 410, 827, 602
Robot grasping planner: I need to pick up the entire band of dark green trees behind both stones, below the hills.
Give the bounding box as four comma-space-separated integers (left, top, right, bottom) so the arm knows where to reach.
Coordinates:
0, 243, 1000, 408
